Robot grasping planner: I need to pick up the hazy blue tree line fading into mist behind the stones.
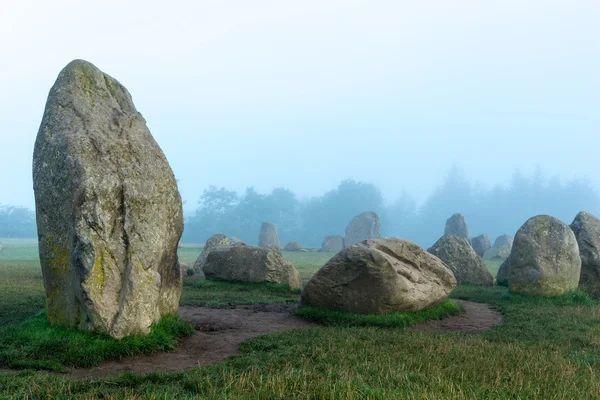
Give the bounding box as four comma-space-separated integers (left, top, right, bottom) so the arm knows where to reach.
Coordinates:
183, 168, 600, 247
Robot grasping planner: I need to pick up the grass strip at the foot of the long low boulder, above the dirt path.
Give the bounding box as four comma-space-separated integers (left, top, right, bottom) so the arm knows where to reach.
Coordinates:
180, 280, 301, 307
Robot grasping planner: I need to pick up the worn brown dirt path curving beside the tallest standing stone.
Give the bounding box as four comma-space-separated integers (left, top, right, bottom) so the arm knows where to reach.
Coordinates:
70, 304, 317, 379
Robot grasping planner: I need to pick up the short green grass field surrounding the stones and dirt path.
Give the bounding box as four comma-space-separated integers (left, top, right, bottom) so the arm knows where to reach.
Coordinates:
0, 240, 600, 399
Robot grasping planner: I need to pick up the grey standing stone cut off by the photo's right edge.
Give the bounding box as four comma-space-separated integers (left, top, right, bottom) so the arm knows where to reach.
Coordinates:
571, 212, 600, 298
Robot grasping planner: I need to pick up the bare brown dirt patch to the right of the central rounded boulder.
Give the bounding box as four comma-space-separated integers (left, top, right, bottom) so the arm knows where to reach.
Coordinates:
410, 300, 502, 333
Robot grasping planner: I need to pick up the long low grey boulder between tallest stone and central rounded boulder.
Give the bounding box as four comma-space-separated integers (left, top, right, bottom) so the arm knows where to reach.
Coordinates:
204, 243, 302, 289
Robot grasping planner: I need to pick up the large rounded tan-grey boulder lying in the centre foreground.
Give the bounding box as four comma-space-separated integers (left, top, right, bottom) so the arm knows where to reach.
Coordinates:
301, 238, 456, 314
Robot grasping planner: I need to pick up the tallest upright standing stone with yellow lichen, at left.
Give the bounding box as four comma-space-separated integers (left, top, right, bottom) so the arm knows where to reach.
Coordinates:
33, 60, 183, 338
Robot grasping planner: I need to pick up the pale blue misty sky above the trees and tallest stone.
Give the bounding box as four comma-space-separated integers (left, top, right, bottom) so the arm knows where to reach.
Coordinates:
0, 0, 600, 210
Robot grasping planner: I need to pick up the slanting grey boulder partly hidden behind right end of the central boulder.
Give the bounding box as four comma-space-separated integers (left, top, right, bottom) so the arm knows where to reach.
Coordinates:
427, 235, 494, 286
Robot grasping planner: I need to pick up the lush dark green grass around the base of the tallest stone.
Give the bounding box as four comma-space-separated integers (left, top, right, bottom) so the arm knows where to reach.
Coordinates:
0, 312, 194, 372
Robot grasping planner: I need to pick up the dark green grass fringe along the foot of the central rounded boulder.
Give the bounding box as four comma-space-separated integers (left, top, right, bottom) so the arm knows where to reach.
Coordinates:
296, 300, 463, 328
